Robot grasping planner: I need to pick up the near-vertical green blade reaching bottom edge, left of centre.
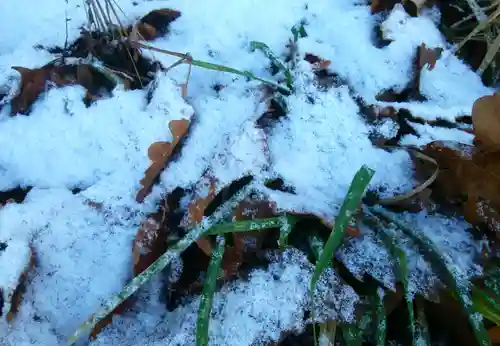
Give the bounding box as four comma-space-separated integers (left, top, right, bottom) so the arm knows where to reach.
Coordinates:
196, 237, 225, 346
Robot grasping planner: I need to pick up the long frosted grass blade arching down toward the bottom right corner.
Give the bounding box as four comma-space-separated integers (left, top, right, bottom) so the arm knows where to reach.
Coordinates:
370, 207, 491, 346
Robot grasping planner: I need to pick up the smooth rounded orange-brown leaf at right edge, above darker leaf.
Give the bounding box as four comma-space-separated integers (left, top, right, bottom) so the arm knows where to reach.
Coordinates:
472, 93, 500, 151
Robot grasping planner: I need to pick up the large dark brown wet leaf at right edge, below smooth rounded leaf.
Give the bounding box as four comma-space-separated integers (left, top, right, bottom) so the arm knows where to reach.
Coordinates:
414, 141, 500, 234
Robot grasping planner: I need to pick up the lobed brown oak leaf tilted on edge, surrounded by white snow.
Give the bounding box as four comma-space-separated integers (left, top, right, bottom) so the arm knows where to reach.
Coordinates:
136, 119, 190, 203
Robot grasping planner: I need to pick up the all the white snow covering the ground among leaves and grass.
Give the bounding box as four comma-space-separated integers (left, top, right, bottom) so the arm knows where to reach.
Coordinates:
0, 0, 491, 346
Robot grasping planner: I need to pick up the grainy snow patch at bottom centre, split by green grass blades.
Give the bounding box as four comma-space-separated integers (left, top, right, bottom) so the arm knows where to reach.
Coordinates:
92, 249, 358, 346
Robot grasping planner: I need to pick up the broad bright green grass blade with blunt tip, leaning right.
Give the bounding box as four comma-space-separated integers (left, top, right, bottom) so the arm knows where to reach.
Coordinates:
309, 166, 375, 294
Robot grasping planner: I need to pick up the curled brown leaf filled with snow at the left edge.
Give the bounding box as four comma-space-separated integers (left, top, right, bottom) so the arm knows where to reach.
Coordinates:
0, 240, 35, 322
